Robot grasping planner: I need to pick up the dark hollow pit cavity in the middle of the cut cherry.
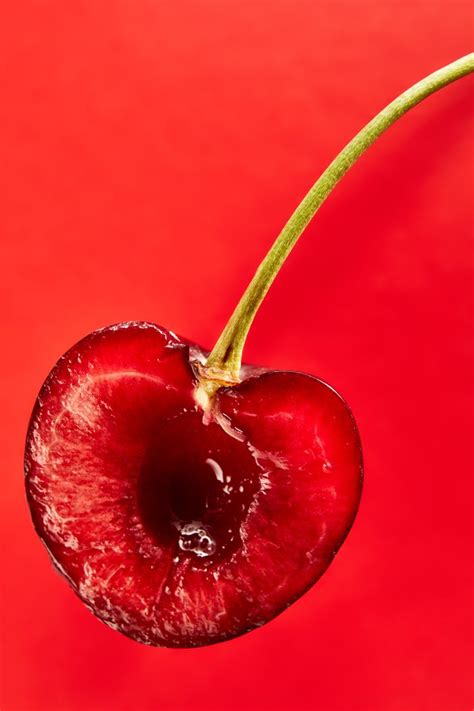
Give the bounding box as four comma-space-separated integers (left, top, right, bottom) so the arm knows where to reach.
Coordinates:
137, 413, 261, 565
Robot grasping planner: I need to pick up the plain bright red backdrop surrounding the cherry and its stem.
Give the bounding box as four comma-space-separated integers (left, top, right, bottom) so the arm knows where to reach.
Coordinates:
0, 0, 472, 711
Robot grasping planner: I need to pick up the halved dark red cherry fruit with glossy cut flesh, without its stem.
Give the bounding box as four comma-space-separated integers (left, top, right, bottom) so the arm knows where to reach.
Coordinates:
25, 323, 362, 647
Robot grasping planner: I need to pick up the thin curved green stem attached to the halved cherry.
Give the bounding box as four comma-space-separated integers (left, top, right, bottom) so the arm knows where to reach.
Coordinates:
202, 53, 474, 389
